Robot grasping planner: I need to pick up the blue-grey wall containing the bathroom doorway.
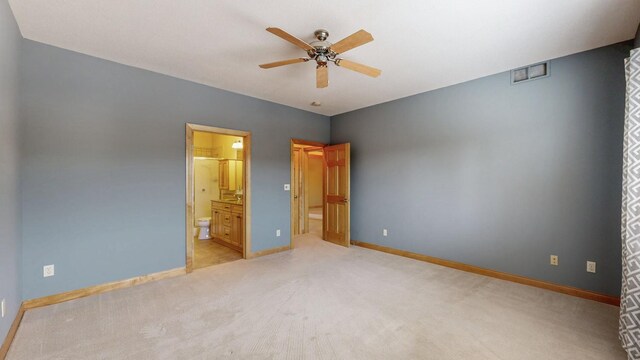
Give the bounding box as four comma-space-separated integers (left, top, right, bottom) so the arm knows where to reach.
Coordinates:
21, 40, 329, 299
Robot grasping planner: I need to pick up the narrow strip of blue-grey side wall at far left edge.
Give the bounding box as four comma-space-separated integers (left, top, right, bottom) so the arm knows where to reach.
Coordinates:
0, 1, 22, 344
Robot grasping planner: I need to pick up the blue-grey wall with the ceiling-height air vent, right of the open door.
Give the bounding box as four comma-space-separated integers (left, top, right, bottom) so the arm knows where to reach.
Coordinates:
331, 45, 629, 296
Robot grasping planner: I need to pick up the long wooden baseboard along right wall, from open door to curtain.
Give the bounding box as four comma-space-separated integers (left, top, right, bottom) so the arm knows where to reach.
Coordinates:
351, 240, 620, 306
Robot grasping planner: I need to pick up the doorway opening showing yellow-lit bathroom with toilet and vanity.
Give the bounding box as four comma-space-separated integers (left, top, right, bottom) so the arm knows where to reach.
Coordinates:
186, 124, 251, 272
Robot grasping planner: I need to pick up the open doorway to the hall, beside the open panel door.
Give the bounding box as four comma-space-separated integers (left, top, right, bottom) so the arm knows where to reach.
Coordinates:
291, 140, 325, 239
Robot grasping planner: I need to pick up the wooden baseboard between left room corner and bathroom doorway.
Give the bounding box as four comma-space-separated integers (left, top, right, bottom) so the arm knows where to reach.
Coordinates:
23, 267, 186, 310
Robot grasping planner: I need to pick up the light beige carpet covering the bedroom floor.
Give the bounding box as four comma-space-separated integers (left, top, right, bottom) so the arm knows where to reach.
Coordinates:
8, 235, 626, 360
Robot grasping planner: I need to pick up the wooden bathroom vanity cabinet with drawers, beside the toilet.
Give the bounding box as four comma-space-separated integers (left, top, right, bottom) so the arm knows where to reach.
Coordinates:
211, 201, 244, 252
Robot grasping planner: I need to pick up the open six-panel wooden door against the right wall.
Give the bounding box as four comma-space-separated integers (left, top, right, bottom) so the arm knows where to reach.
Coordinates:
322, 143, 351, 247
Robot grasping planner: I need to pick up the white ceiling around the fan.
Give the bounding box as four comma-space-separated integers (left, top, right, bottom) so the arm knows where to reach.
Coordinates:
9, 0, 640, 115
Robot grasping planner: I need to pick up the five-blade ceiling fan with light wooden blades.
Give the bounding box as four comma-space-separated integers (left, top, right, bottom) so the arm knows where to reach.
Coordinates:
260, 27, 382, 88
